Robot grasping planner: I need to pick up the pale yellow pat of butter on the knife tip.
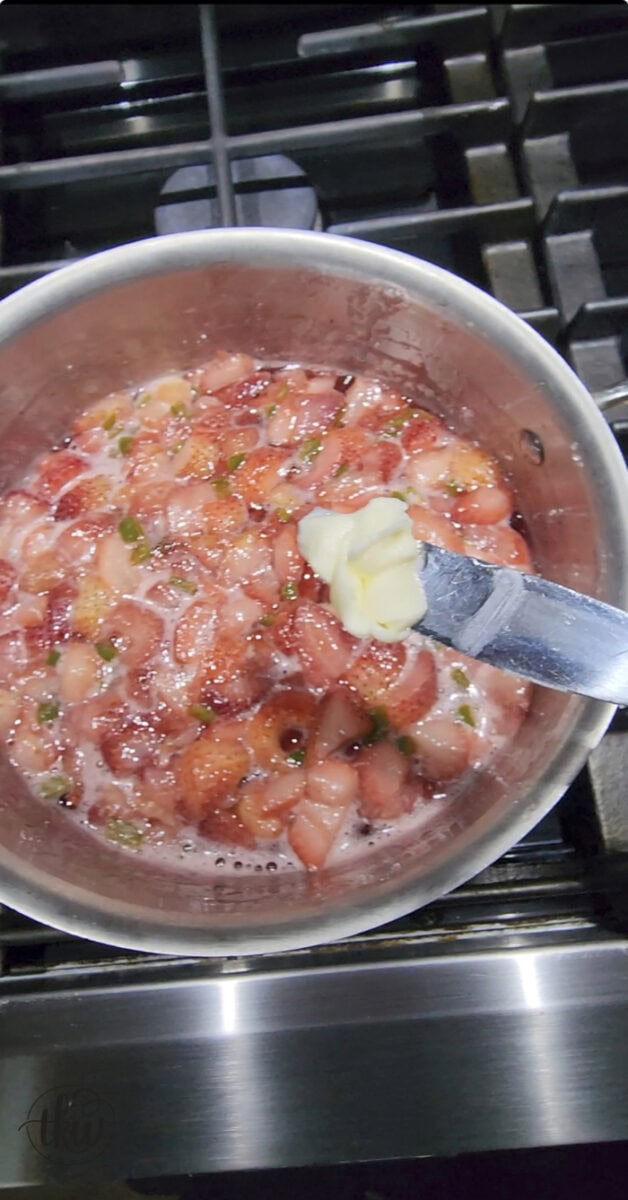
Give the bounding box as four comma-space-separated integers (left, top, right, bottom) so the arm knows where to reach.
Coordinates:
299, 497, 427, 642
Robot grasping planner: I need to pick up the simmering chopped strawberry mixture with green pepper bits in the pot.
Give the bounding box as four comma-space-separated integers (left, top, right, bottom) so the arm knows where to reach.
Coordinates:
0, 353, 531, 868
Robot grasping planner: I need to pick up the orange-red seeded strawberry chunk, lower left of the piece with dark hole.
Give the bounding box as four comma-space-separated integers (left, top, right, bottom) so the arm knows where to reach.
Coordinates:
177, 730, 250, 821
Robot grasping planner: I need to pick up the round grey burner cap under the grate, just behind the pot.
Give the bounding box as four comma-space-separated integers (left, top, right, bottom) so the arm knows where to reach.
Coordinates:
155, 155, 322, 234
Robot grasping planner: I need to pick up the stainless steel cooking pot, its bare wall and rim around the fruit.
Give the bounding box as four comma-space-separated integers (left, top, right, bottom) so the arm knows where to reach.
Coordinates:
0, 229, 628, 955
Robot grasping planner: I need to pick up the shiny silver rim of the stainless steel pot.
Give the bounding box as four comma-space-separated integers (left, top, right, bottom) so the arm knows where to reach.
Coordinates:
0, 228, 628, 956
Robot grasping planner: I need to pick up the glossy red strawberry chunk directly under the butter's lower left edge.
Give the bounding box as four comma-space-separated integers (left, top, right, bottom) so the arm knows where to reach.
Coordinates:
292, 601, 359, 688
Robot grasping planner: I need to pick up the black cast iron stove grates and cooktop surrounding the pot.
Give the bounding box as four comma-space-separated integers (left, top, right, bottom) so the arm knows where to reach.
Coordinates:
0, 4, 628, 986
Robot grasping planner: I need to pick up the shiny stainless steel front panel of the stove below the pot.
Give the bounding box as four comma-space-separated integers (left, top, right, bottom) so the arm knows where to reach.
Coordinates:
0, 931, 628, 1186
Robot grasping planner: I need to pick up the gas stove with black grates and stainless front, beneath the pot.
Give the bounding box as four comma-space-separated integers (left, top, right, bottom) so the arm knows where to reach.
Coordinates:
0, 4, 628, 1187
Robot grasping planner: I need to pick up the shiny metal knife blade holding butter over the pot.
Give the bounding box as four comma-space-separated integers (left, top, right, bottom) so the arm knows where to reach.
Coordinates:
414, 544, 628, 704
